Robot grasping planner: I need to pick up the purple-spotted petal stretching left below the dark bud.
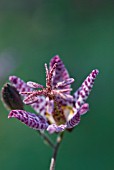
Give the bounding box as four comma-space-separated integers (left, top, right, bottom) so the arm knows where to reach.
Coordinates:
8, 110, 48, 130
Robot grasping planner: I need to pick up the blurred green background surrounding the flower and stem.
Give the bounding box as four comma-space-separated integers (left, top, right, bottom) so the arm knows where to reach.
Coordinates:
0, 0, 114, 170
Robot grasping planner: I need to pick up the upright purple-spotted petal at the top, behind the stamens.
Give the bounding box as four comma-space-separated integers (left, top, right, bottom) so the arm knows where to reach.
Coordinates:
50, 55, 70, 88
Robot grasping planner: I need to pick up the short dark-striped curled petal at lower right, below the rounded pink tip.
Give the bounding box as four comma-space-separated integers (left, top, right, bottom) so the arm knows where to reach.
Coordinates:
66, 112, 80, 129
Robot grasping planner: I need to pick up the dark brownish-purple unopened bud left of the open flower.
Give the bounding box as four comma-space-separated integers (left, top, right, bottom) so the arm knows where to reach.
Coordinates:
1, 83, 24, 110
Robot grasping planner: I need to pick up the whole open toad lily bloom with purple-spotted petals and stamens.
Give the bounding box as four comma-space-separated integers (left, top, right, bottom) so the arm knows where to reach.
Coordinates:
8, 55, 99, 133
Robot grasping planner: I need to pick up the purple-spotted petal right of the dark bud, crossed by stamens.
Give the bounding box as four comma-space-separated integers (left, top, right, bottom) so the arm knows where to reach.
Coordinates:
9, 76, 46, 115
